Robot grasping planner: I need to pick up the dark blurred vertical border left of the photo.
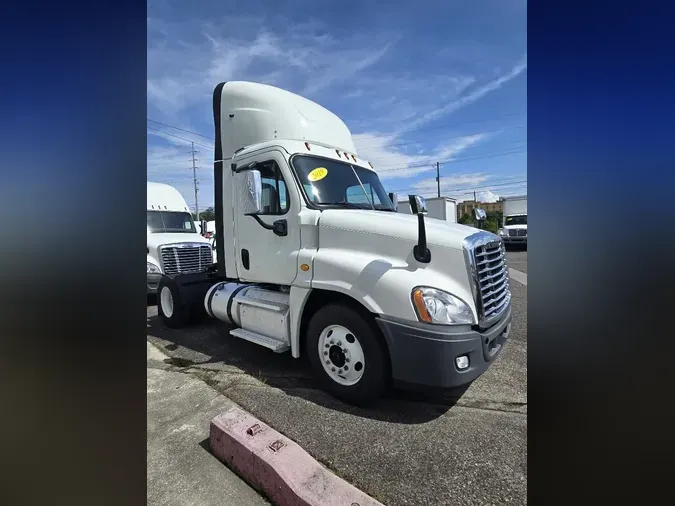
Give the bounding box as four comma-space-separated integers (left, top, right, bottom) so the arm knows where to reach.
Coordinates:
0, 0, 146, 505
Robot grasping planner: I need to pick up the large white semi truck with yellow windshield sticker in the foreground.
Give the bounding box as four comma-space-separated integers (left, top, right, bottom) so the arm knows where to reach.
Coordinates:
158, 82, 511, 404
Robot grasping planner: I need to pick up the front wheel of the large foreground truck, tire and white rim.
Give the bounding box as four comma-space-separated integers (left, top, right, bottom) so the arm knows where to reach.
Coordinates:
305, 304, 389, 405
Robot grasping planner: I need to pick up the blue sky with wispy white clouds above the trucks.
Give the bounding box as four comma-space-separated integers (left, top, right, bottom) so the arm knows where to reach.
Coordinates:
147, 0, 527, 209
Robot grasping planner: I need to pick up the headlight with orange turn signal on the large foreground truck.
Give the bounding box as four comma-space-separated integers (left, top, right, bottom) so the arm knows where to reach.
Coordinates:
412, 286, 474, 325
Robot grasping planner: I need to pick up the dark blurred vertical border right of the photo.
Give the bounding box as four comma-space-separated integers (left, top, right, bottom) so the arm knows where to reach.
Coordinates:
528, 1, 675, 504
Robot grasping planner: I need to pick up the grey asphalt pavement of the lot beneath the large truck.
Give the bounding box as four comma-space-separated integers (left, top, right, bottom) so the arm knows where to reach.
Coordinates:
148, 251, 527, 506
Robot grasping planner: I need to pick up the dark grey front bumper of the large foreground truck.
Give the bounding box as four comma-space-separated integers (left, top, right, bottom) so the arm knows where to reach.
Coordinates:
377, 306, 511, 390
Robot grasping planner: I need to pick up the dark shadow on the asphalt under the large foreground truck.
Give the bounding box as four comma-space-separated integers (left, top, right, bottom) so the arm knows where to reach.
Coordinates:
147, 316, 466, 424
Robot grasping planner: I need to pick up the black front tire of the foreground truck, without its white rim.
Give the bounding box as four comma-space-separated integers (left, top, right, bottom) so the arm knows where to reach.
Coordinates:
304, 304, 390, 406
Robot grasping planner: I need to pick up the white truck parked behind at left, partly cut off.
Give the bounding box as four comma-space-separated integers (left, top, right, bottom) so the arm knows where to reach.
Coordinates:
147, 181, 213, 294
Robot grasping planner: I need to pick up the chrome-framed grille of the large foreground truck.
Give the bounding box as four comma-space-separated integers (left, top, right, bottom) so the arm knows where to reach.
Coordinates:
465, 233, 511, 326
